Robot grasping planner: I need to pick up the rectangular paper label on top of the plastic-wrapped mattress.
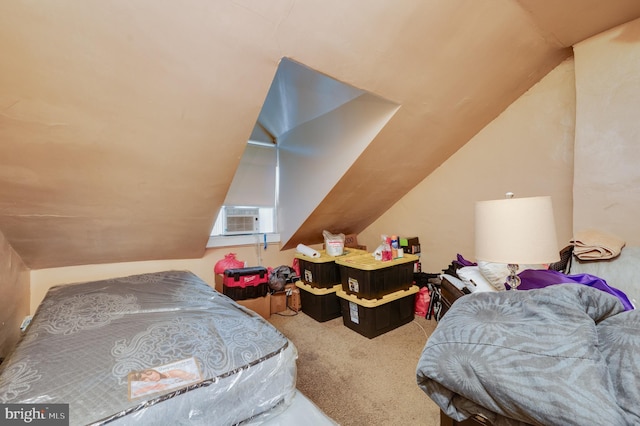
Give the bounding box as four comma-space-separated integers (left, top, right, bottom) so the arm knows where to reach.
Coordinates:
127, 357, 202, 399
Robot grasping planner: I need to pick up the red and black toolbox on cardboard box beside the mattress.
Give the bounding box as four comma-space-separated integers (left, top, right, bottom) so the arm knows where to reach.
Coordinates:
222, 266, 269, 300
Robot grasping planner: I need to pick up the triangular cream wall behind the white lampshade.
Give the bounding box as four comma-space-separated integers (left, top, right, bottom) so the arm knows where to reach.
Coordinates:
358, 59, 575, 272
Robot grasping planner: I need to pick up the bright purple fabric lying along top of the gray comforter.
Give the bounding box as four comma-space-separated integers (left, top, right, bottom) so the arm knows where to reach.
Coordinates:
518, 269, 633, 311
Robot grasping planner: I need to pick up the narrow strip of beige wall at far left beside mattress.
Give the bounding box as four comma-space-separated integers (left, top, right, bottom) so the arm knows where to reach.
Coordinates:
0, 232, 29, 358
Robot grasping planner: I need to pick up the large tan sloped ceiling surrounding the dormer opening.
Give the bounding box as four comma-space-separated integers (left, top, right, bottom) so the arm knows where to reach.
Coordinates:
0, 0, 640, 269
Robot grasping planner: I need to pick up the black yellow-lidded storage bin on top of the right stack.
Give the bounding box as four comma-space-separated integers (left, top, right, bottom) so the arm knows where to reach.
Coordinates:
336, 254, 419, 299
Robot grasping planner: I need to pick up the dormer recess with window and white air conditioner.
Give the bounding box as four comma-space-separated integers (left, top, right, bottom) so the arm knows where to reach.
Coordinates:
209, 58, 399, 247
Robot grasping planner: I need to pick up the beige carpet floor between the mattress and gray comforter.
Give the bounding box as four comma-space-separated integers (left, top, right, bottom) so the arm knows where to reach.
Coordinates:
270, 311, 440, 426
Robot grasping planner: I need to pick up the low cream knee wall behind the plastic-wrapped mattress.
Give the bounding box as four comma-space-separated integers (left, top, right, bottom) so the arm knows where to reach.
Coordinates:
30, 244, 302, 314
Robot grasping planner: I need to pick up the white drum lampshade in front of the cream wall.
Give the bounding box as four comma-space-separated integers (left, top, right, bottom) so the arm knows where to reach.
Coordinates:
475, 197, 560, 265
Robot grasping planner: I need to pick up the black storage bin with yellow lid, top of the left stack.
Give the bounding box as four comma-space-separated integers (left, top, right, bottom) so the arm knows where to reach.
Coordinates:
295, 248, 367, 288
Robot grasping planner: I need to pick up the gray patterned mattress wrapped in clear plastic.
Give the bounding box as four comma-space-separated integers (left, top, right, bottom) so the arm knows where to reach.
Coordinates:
0, 271, 297, 425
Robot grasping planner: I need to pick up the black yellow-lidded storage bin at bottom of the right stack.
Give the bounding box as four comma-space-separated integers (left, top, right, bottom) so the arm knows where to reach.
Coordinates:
336, 285, 419, 339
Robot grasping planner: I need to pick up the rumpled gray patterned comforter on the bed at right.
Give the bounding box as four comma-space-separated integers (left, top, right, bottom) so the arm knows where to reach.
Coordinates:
417, 284, 640, 426
